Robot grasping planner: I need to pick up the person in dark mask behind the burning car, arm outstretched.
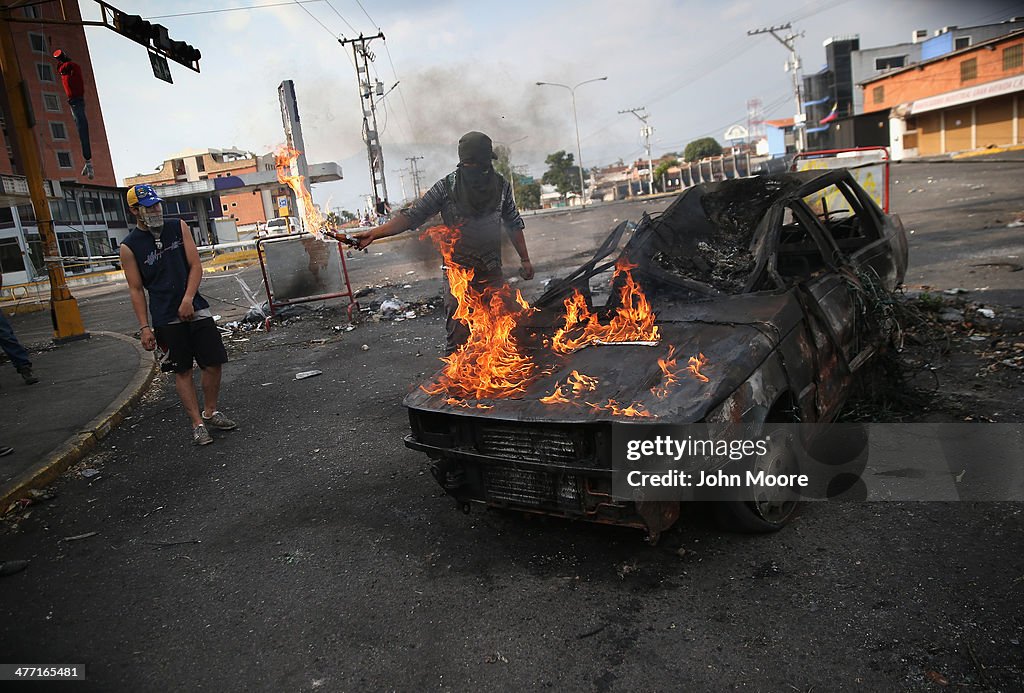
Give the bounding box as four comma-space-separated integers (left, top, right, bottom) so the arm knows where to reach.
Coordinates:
352, 132, 534, 354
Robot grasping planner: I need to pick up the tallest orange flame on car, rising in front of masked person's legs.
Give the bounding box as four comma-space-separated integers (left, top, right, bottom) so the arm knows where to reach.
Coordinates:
423, 226, 535, 399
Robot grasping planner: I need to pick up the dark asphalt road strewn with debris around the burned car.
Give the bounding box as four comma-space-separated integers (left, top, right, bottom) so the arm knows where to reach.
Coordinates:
0, 159, 1024, 691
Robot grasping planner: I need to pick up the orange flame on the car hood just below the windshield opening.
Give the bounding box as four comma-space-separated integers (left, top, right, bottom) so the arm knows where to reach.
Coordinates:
551, 258, 662, 354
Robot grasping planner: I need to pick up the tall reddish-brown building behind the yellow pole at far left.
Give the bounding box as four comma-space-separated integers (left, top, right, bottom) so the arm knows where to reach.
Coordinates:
0, 2, 128, 289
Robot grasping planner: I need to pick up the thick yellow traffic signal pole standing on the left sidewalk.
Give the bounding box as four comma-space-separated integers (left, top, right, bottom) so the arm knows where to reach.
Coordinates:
0, 9, 89, 342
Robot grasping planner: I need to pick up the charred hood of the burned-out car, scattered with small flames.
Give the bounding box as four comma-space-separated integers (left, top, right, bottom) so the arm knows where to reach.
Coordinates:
403, 294, 801, 423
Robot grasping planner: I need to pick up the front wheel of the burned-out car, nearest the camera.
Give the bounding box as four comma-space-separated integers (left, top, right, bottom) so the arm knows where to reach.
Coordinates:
715, 427, 800, 534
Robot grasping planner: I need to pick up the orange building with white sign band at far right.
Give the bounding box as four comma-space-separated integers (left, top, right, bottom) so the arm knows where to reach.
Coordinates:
861, 30, 1024, 160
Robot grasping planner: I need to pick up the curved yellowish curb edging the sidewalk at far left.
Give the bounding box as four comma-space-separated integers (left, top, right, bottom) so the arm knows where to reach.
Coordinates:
0, 331, 157, 516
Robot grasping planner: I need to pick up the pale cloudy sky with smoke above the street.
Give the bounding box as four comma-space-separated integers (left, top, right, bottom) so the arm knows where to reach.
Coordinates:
80, 0, 1024, 211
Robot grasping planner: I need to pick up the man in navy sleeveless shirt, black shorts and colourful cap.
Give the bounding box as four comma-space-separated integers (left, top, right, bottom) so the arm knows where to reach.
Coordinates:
121, 185, 238, 445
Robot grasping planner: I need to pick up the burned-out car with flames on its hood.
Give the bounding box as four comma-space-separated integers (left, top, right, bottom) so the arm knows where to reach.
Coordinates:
404, 169, 907, 538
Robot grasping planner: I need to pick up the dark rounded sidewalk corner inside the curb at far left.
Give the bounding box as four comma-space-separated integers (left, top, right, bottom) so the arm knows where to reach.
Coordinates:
0, 332, 155, 514
